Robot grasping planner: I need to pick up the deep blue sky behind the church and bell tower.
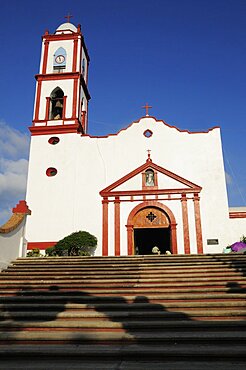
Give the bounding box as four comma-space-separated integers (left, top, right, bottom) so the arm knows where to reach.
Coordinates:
0, 0, 246, 223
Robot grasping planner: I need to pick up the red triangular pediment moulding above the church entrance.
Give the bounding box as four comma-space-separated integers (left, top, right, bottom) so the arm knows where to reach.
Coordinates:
100, 159, 202, 196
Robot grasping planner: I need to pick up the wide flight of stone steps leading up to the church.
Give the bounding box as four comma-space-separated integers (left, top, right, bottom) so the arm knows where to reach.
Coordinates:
0, 254, 246, 370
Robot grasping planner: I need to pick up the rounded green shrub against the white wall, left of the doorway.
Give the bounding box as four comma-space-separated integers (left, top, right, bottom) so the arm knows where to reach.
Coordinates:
46, 231, 97, 256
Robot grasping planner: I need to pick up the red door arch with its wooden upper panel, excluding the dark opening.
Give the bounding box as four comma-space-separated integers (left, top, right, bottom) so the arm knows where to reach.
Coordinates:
126, 201, 177, 255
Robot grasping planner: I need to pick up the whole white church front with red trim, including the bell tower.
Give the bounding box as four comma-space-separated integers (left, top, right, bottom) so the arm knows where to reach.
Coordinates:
25, 23, 246, 256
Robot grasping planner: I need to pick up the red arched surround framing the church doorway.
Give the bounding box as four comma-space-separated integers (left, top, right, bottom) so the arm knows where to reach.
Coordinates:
126, 201, 178, 255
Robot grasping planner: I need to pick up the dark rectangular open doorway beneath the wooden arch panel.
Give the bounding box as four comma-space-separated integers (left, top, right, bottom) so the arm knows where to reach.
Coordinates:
134, 228, 171, 254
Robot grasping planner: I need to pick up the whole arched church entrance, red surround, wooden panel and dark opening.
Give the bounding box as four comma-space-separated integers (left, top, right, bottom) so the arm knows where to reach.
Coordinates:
127, 201, 177, 254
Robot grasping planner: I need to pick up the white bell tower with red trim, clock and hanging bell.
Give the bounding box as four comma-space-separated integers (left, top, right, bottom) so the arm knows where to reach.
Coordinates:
30, 22, 90, 135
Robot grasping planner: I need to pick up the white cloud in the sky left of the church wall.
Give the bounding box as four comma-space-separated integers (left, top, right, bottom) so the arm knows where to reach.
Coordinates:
0, 121, 29, 225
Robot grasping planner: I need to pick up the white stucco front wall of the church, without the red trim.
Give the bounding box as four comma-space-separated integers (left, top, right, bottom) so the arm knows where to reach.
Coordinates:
26, 117, 242, 254
